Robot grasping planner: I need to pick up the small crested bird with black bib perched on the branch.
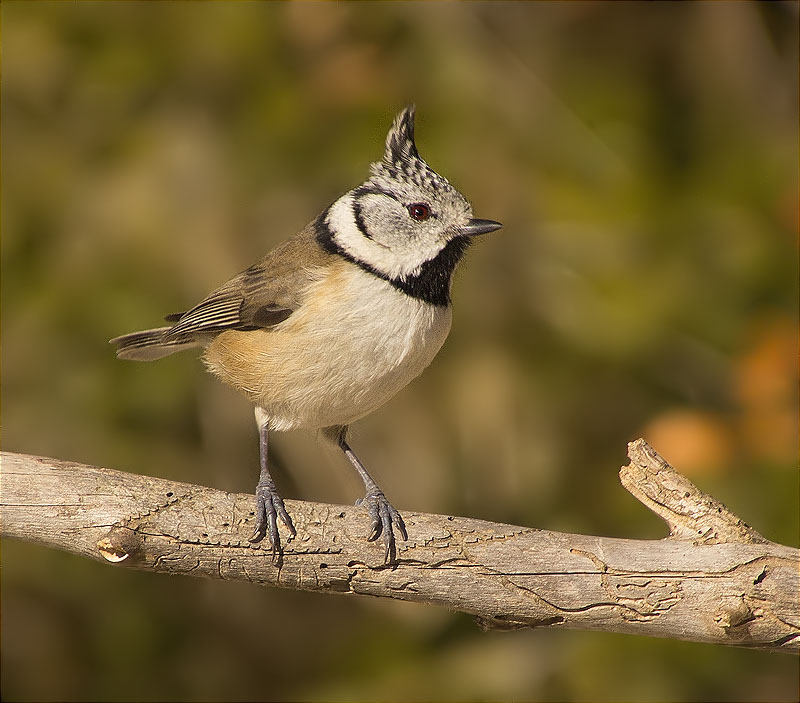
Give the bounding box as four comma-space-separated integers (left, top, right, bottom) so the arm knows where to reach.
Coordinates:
110, 105, 502, 565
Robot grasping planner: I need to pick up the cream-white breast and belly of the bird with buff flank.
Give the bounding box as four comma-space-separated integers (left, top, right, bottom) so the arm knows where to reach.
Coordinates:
206, 265, 452, 430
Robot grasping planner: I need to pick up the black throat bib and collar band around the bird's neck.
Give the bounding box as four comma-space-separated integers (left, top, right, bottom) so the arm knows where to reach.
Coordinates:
314, 211, 470, 307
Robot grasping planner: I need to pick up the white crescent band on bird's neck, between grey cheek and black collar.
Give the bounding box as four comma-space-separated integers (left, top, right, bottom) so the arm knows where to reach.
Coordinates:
325, 193, 442, 278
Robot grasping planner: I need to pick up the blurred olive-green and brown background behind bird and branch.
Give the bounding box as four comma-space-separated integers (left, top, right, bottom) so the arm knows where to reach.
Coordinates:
2, 1, 798, 701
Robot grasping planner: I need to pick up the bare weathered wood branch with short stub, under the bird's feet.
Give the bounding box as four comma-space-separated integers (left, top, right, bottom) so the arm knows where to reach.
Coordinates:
0, 440, 800, 652
